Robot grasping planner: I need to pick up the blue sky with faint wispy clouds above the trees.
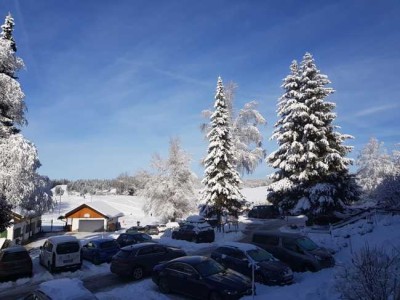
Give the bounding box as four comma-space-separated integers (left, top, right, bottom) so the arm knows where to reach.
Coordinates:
0, 0, 400, 179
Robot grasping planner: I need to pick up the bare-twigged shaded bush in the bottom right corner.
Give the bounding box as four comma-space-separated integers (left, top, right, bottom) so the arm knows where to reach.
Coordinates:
336, 245, 400, 300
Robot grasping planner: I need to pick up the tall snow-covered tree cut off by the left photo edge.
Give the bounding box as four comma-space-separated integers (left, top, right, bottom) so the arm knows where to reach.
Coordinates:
0, 15, 51, 214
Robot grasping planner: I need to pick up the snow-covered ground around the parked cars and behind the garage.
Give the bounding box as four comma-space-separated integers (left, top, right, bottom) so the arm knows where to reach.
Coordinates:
0, 187, 400, 300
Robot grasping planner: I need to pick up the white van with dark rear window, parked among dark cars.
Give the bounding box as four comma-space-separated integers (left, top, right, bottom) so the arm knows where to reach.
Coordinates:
39, 235, 82, 272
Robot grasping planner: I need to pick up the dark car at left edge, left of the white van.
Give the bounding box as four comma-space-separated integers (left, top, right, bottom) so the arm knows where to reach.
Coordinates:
0, 246, 32, 281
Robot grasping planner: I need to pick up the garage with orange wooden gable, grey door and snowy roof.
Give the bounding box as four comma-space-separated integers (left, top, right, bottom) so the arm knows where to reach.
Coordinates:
65, 202, 124, 232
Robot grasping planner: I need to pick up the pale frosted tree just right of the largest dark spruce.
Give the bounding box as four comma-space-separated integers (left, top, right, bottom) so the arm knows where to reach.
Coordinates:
356, 138, 394, 196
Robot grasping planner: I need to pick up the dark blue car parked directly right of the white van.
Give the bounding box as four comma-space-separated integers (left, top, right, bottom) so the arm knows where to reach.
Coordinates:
82, 238, 120, 265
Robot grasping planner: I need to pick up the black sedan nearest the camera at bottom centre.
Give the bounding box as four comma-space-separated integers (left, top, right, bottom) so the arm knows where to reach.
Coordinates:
152, 256, 252, 300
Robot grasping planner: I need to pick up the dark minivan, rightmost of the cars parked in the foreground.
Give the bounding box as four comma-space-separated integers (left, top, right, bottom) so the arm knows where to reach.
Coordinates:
252, 231, 335, 272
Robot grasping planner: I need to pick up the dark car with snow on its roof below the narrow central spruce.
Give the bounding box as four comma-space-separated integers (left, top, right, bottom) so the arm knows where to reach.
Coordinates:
171, 216, 215, 243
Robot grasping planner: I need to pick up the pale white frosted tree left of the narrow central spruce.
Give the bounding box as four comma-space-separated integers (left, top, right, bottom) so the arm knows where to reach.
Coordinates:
139, 138, 196, 221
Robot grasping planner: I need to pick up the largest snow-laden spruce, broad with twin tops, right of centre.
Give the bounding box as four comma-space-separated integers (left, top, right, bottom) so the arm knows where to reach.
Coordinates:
267, 53, 358, 218
